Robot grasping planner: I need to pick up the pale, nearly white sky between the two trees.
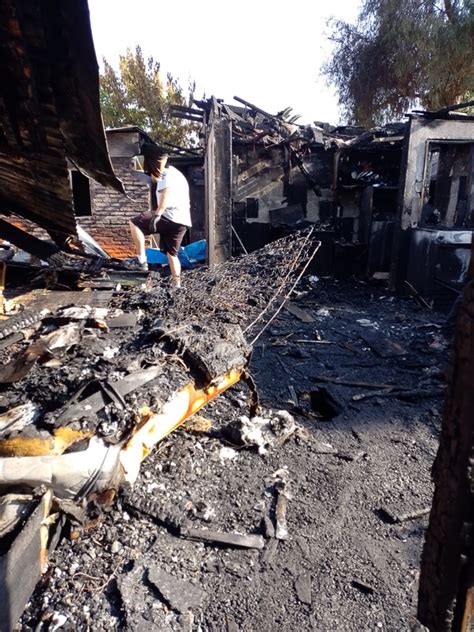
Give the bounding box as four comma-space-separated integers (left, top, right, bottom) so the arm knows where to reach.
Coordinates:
89, 0, 359, 124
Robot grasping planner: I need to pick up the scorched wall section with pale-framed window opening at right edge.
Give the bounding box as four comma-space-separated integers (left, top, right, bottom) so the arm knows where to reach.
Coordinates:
392, 108, 474, 309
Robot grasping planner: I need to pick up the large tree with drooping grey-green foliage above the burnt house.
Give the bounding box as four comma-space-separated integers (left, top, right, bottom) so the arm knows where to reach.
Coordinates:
323, 0, 474, 126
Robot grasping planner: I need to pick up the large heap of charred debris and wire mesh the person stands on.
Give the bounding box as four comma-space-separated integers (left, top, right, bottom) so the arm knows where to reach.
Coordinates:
0, 231, 318, 622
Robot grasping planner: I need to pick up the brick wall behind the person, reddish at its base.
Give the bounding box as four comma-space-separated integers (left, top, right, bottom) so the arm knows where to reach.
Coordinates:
77, 158, 148, 257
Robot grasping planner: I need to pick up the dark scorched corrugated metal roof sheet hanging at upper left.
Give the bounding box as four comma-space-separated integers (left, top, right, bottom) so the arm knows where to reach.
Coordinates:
0, 0, 124, 239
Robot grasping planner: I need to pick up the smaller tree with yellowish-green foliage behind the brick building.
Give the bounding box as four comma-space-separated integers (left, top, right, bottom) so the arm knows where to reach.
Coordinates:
100, 46, 196, 145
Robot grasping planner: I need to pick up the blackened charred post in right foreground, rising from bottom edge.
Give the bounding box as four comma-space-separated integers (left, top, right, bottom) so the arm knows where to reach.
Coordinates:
418, 238, 474, 632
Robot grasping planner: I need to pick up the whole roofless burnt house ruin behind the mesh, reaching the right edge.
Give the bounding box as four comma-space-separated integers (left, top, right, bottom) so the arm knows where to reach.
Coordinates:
180, 97, 474, 309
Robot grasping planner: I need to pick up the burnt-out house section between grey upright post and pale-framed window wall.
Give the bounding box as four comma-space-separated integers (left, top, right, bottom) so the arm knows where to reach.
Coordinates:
180, 97, 407, 276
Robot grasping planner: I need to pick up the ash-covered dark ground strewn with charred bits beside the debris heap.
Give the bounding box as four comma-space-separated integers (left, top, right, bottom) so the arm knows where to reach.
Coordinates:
17, 279, 447, 632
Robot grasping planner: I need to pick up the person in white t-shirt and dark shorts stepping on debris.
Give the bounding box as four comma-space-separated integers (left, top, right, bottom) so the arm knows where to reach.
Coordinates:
130, 143, 191, 288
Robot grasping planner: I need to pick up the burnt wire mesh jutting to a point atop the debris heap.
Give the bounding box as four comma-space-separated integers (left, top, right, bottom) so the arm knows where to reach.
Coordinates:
117, 228, 319, 344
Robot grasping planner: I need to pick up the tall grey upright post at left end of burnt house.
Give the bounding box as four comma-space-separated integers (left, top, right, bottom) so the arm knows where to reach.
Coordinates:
204, 99, 232, 265
